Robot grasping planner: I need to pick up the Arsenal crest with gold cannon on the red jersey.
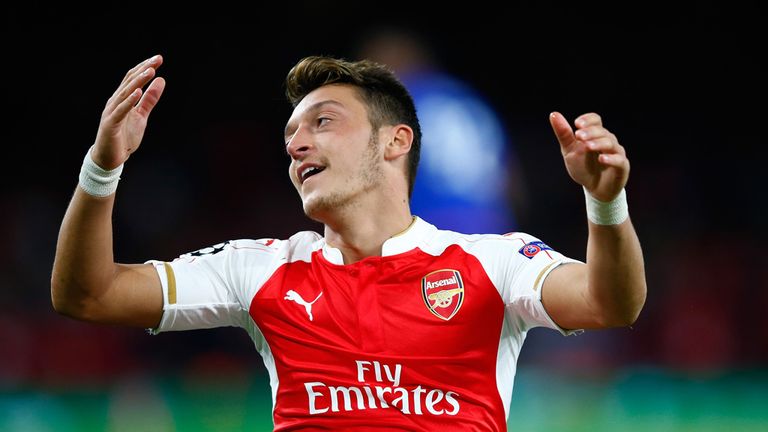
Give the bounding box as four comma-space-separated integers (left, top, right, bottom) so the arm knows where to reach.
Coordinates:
421, 269, 464, 321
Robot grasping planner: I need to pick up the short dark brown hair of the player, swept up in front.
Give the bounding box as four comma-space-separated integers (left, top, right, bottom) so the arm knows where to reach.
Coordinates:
285, 56, 421, 197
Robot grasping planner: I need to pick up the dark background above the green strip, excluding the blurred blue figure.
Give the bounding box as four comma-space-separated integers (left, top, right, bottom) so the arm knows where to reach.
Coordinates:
0, 2, 768, 391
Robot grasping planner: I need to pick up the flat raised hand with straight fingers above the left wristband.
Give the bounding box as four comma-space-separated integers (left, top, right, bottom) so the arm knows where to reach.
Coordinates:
91, 55, 165, 170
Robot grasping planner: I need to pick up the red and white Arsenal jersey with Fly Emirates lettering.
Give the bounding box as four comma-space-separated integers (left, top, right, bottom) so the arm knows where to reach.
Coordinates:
150, 218, 575, 431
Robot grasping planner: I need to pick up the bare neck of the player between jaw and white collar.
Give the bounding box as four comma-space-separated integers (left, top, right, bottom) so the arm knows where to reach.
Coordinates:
325, 194, 413, 264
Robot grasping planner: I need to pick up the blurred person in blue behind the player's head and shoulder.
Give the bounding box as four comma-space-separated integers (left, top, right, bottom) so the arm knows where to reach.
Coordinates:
357, 28, 525, 233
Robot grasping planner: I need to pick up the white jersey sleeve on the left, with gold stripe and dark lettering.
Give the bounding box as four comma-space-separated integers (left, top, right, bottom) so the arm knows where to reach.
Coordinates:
147, 240, 278, 334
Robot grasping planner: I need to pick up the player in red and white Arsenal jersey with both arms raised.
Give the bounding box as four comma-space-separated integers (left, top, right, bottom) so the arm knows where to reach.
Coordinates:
51, 55, 646, 431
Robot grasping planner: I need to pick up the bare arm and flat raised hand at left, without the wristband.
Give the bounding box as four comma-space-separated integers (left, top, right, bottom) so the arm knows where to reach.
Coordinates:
51, 56, 170, 328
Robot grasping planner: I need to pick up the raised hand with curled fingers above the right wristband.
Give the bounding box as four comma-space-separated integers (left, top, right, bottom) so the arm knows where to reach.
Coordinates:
549, 112, 629, 202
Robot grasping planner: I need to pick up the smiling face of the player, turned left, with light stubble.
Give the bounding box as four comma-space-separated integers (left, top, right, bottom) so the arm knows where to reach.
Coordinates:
285, 84, 383, 220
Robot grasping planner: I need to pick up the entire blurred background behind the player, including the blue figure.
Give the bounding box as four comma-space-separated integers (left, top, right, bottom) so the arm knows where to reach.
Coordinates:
0, 1, 768, 431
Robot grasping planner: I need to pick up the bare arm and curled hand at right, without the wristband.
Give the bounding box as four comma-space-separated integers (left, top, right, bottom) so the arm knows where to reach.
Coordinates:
542, 113, 646, 329
